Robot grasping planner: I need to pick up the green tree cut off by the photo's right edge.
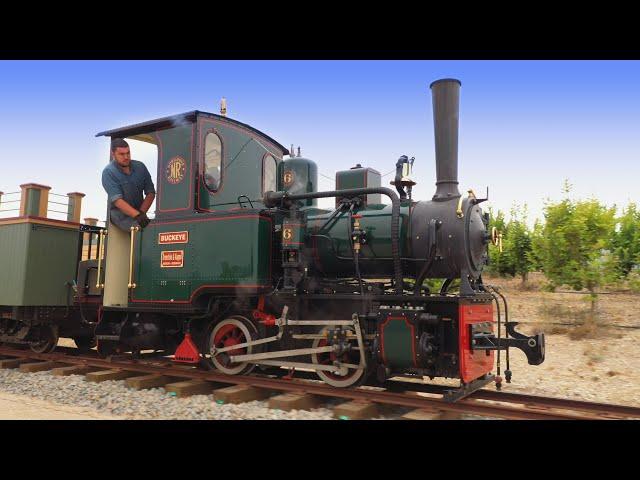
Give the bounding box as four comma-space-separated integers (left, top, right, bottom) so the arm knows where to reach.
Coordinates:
611, 203, 640, 277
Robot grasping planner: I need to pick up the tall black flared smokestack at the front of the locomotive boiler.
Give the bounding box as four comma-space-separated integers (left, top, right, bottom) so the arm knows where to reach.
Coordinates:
430, 78, 462, 200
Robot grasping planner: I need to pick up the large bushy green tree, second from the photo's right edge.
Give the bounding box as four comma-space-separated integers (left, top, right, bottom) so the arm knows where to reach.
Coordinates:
533, 182, 615, 314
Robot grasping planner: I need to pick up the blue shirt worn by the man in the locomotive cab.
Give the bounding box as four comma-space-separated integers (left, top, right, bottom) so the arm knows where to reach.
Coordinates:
102, 160, 156, 230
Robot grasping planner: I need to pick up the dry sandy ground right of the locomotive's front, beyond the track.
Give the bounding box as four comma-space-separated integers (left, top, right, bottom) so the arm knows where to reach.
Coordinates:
484, 274, 640, 406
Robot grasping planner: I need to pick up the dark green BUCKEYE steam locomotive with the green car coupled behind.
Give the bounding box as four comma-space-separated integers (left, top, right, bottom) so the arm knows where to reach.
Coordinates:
0, 79, 545, 400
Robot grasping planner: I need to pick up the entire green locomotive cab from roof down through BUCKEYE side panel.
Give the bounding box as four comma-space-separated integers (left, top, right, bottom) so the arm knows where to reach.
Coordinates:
97, 111, 288, 340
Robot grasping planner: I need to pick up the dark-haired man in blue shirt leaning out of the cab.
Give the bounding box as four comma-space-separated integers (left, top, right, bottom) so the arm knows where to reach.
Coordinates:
102, 138, 156, 231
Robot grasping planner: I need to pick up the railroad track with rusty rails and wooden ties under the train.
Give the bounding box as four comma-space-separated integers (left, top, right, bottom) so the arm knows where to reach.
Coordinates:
0, 347, 640, 420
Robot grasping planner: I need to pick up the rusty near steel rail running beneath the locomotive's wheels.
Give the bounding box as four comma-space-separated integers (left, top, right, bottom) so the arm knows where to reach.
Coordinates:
0, 347, 640, 420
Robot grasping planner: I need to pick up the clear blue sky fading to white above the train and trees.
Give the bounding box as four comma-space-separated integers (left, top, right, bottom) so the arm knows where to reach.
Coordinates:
0, 60, 640, 225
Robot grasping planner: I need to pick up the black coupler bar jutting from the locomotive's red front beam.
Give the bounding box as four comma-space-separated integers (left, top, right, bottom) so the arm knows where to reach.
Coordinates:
470, 322, 545, 365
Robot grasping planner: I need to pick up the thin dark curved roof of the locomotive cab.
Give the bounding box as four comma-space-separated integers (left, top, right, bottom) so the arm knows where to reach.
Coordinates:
96, 110, 289, 155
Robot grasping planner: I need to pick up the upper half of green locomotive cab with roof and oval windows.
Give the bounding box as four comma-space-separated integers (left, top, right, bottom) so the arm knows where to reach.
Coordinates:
96, 111, 289, 220
